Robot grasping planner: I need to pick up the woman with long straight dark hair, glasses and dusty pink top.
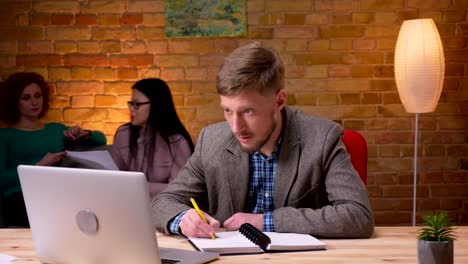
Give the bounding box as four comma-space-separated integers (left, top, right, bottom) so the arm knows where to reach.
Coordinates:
110, 78, 193, 198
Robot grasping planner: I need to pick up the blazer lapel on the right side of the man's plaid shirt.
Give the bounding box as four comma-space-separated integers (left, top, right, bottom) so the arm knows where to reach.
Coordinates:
275, 107, 300, 208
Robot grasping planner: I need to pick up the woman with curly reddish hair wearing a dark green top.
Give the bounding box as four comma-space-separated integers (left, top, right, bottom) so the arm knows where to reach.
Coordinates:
0, 72, 106, 226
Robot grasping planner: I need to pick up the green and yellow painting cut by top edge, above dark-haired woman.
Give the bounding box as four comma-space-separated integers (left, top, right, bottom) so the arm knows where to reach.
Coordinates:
165, 0, 247, 38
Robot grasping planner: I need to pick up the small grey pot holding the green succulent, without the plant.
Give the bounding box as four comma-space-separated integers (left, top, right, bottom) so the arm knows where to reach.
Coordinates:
418, 240, 453, 264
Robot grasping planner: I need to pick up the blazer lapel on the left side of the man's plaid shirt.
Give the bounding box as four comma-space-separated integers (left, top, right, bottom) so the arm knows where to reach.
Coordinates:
223, 137, 249, 213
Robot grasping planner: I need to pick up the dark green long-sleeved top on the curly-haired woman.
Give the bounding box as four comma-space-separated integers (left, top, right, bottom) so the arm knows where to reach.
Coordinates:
0, 123, 106, 199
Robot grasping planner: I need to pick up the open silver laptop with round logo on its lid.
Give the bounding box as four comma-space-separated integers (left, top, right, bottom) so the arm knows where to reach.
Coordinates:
18, 165, 218, 264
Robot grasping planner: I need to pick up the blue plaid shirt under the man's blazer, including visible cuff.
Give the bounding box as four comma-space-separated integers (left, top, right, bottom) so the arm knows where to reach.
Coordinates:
169, 139, 281, 235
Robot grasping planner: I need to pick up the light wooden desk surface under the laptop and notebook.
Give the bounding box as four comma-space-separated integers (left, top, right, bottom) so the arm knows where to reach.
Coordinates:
0, 226, 468, 264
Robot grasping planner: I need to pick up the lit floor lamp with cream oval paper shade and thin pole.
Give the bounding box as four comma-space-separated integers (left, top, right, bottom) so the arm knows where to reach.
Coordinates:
395, 19, 445, 226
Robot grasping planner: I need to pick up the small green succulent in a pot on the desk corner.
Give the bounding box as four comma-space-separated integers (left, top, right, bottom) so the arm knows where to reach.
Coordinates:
418, 212, 456, 264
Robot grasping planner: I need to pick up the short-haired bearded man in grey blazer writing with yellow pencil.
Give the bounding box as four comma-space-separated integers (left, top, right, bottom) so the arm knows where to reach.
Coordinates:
152, 42, 374, 237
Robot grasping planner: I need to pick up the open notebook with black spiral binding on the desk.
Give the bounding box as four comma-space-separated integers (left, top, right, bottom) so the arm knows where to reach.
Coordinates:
189, 224, 326, 255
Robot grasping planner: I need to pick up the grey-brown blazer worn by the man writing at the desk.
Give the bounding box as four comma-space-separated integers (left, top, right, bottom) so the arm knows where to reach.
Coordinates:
151, 107, 374, 237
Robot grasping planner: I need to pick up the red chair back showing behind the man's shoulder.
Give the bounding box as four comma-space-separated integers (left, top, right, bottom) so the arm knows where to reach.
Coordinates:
342, 129, 367, 185
